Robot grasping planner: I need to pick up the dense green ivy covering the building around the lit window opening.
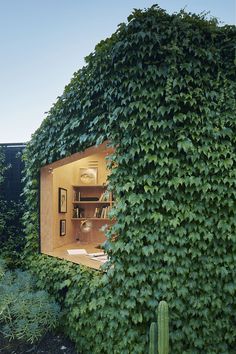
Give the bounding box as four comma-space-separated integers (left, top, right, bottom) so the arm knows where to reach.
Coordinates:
25, 7, 236, 354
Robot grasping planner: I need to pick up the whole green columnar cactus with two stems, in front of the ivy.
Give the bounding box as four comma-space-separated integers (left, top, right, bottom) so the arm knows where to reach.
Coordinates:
149, 301, 169, 354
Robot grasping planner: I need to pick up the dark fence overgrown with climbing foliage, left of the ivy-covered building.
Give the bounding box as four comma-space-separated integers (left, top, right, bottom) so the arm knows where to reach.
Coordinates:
0, 144, 25, 267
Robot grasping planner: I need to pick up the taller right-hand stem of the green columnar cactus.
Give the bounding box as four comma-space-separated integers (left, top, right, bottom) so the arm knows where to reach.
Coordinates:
157, 301, 169, 354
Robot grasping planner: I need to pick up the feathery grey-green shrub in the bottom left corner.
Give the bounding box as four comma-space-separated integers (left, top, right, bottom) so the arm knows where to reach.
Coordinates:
0, 268, 60, 343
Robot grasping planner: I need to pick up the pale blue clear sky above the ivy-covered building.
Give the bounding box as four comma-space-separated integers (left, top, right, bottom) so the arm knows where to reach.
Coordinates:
0, 0, 236, 143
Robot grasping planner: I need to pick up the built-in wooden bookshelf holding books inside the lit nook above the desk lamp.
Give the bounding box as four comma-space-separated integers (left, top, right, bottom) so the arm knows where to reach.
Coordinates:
72, 185, 114, 221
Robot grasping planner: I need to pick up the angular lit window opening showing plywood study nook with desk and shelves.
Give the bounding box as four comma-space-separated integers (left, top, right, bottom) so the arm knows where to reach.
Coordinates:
40, 143, 114, 269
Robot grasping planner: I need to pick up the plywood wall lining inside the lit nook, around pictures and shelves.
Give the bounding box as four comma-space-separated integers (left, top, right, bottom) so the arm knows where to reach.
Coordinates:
41, 144, 112, 253
